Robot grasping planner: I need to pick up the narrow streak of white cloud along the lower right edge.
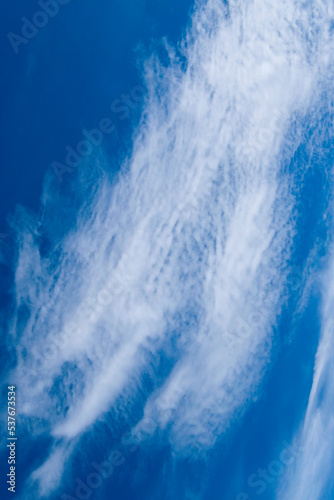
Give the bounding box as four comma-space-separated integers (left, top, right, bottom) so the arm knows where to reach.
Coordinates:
279, 246, 334, 500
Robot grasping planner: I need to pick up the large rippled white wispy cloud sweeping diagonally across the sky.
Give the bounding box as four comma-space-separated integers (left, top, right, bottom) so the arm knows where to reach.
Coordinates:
5, 0, 332, 492
